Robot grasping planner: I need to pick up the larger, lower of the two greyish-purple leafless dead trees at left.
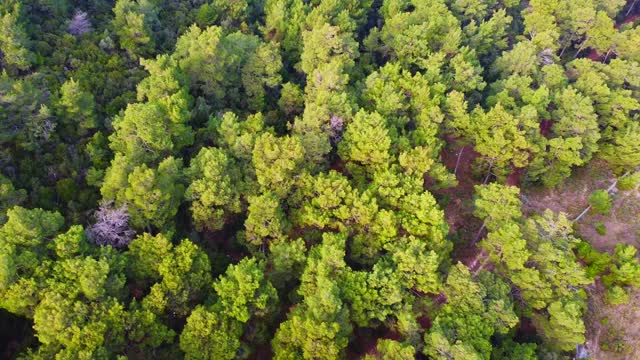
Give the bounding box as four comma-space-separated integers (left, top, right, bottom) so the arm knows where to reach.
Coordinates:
88, 202, 135, 248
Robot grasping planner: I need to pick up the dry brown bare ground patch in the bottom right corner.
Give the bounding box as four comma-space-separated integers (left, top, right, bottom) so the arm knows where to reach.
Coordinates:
585, 284, 640, 360
